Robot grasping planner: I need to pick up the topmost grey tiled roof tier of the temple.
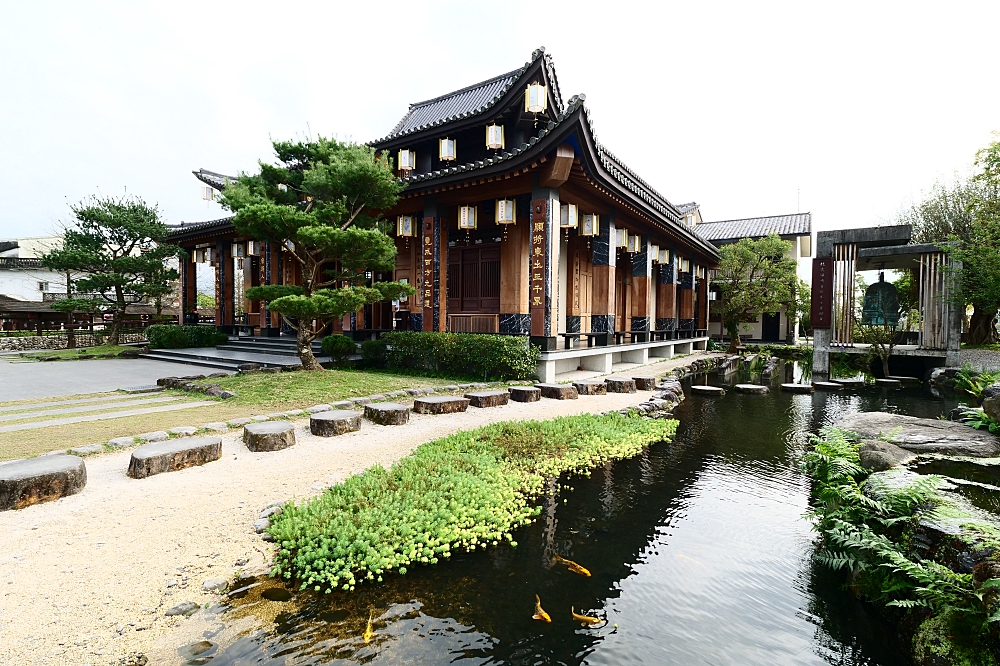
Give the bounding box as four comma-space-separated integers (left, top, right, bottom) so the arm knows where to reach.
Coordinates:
372, 47, 562, 144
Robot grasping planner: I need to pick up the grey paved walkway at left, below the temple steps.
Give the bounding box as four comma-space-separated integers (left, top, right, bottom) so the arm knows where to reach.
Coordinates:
0, 357, 228, 402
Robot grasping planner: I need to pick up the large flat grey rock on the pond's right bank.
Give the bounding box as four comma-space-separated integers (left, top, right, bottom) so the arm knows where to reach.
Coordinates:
834, 412, 1000, 458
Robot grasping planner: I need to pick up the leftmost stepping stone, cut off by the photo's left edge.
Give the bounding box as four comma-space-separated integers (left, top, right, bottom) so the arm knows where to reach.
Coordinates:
0, 454, 87, 511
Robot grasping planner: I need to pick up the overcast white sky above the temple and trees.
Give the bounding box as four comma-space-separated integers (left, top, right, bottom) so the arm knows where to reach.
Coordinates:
0, 0, 1000, 238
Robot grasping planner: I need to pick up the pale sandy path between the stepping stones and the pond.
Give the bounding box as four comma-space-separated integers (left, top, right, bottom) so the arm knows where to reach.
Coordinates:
0, 357, 708, 666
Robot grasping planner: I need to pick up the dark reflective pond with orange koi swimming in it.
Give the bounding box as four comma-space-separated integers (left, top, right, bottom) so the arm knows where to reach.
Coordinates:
197, 364, 976, 666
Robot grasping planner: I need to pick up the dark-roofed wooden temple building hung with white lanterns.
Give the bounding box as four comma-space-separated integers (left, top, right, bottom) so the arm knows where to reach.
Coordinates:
171, 49, 718, 381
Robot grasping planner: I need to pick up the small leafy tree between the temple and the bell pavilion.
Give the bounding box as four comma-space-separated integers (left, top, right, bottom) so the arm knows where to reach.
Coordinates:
713, 234, 797, 354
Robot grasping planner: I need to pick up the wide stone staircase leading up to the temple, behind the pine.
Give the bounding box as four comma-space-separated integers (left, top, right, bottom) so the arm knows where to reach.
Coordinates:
142, 336, 330, 372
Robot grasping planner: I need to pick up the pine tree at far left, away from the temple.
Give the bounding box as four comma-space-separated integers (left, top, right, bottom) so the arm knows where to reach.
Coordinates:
41, 197, 182, 345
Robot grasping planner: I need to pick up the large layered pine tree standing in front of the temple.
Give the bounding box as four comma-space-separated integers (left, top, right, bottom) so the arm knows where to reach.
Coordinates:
221, 137, 414, 370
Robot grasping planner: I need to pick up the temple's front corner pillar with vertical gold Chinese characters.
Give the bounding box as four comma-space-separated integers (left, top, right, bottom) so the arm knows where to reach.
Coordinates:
529, 180, 559, 351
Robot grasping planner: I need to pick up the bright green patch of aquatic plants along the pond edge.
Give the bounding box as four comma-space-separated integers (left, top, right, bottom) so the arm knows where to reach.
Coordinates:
268, 414, 677, 592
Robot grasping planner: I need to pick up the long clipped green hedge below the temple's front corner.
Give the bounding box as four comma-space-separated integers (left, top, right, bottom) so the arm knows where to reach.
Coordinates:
361, 331, 541, 379
